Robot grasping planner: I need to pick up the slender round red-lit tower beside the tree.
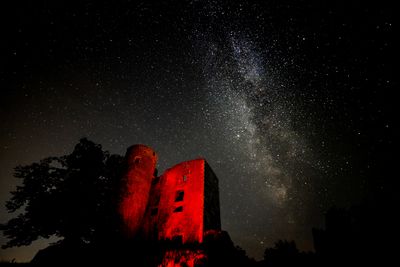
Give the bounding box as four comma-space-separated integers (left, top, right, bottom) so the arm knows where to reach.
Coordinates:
119, 145, 157, 237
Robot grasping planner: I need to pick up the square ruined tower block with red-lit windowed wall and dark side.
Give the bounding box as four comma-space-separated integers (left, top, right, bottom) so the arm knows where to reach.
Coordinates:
143, 159, 221, 243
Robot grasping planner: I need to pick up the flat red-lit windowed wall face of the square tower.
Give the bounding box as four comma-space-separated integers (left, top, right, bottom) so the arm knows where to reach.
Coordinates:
158, 159, 204, 243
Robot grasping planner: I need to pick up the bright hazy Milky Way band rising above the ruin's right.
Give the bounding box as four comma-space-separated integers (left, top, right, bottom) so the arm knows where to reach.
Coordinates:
192, 29, 323, 255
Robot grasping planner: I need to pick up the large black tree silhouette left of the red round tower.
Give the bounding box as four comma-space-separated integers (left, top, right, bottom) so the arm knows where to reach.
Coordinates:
0, 138, 123, 248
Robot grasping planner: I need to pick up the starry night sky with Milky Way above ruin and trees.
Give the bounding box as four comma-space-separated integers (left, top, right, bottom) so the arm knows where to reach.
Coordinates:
0, 0, 397, 261
